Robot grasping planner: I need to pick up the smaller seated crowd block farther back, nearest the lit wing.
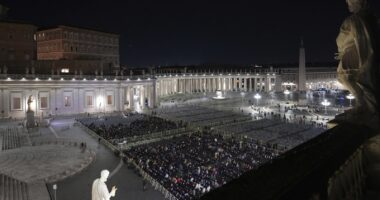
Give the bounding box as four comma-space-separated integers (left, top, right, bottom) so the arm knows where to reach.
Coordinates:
78, 113, 180, 144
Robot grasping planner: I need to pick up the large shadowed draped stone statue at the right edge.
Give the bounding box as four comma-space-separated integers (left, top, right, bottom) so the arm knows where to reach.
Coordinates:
336, 0, 380, 122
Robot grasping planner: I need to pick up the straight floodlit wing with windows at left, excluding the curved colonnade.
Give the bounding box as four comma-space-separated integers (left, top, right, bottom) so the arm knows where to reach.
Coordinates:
0, 77, 155, 118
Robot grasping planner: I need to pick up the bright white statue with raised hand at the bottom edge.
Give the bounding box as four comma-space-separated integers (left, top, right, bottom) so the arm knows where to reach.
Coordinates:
92, 169, 117, 200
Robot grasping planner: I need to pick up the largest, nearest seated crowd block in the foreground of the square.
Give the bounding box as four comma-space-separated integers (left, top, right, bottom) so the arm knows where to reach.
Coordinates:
124, 133, 277, 199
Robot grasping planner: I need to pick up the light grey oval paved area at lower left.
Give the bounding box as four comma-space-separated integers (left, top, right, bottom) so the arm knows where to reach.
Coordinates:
0, 144, 94, 183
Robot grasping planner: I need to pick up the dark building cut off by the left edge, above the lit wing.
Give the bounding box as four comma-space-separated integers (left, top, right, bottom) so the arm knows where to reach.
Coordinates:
0, 20, 37, 72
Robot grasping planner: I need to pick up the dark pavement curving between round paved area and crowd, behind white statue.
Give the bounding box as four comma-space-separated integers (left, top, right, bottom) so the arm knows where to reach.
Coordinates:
50, 119, 164, 200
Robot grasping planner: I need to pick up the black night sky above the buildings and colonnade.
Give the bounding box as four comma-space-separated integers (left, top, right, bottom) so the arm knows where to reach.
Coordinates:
0, 0, 380, 66
